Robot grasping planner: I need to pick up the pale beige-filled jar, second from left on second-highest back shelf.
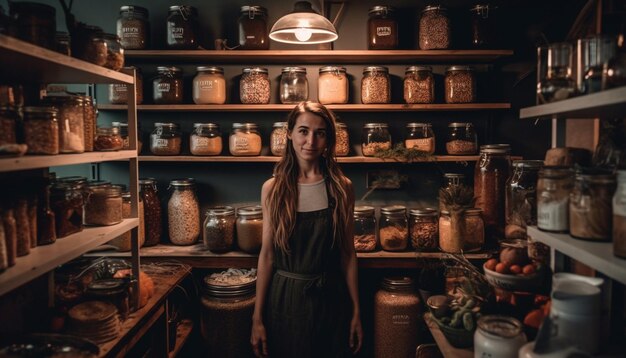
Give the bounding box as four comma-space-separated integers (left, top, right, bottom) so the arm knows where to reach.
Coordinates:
193, 66, 226, 104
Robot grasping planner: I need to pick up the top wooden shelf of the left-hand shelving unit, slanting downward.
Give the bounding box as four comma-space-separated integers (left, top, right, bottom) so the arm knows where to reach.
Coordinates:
0, 35, 133, 83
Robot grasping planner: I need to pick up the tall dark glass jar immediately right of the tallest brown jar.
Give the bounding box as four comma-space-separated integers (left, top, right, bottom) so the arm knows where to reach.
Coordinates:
504, 160, 543, 240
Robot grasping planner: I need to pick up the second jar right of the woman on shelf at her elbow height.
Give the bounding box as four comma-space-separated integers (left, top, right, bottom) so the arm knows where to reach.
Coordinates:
378, 205, 409, 251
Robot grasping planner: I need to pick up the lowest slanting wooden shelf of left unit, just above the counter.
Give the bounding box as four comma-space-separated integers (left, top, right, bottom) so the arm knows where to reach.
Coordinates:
0, 219, 139, 295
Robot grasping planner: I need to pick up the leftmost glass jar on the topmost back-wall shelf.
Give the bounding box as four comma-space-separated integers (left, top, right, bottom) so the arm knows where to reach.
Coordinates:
117, 5, 150, 50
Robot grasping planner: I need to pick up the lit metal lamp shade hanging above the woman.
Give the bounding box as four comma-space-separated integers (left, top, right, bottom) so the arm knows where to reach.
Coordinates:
270, 1, 339, 44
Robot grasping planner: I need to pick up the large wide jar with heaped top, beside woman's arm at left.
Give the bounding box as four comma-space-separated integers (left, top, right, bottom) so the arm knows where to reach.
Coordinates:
200, 269, 256, 357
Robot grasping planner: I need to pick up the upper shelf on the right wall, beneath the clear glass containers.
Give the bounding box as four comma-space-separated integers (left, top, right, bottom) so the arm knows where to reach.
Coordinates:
520, 86, 626, 119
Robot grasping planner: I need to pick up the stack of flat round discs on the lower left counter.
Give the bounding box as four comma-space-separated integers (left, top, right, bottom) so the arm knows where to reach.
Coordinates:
68, 301, 120, 344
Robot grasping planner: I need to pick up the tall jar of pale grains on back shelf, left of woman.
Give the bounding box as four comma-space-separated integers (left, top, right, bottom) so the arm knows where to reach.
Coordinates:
167, 179, 200, 245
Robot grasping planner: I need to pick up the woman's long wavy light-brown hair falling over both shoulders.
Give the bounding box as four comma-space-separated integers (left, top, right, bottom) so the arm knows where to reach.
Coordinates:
266, 101, 353, 253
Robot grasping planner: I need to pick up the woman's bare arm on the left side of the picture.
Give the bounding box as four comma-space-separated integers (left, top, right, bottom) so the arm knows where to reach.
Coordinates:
250, 178, 274, 357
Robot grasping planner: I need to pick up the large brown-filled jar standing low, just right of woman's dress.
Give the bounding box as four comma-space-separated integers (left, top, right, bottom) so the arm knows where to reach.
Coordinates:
374, 277, 422, 358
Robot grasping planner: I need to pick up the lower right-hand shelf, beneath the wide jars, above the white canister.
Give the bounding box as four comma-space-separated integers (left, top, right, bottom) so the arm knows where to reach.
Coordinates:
528, 226, 626, 285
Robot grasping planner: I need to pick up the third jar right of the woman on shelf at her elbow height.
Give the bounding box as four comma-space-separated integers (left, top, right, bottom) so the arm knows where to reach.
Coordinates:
409, 208, 439, 251
